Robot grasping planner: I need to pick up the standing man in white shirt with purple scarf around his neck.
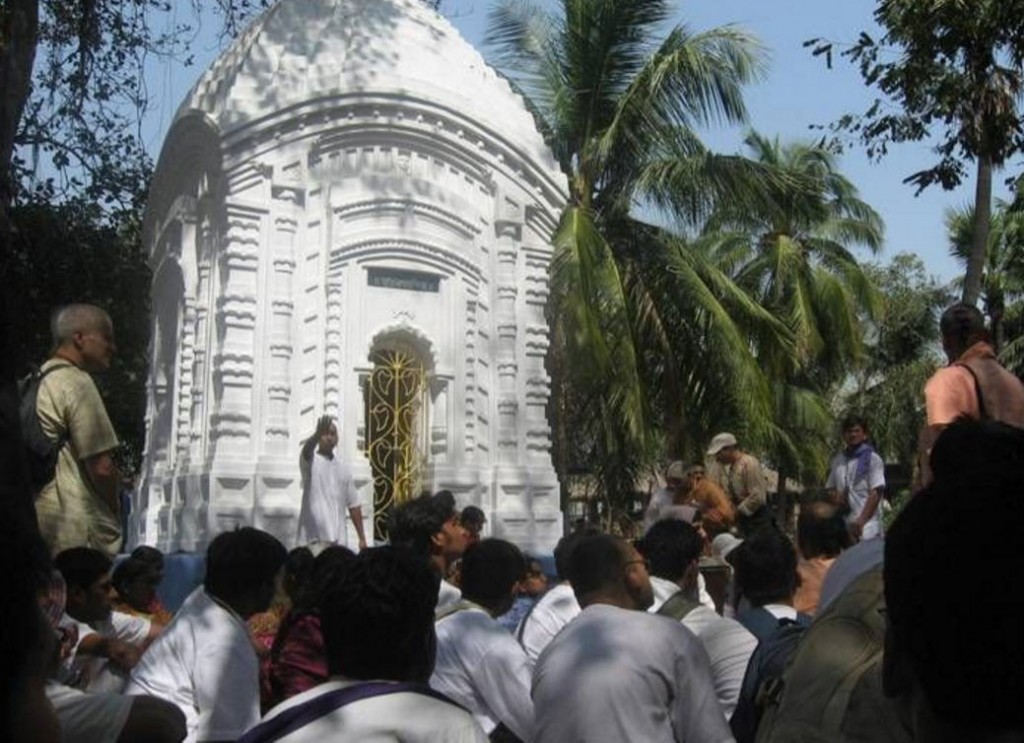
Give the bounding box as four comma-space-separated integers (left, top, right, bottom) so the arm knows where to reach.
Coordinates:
825, 416, 886, 539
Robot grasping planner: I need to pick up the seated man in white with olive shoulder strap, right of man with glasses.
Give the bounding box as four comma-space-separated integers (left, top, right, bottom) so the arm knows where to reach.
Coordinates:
640, 521, 758, 719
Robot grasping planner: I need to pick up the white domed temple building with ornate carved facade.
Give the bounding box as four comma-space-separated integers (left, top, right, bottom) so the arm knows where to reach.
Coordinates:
129, 0, 565, 551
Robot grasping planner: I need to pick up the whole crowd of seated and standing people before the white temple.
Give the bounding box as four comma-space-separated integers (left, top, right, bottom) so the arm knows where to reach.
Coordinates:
0, 306, 1024, 743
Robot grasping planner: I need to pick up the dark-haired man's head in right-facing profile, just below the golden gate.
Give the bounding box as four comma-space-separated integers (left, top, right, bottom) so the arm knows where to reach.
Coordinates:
388, 490, 469, 609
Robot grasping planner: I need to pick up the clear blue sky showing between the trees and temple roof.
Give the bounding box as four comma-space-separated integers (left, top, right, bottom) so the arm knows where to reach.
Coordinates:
143, 0, 1005, 279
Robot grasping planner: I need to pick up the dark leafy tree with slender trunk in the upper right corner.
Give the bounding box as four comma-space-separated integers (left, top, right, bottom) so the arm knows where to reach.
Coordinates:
806, 0, 1024, 304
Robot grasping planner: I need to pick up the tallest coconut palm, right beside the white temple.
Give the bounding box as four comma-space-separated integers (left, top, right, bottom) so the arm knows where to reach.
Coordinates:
488, 0, 791, 503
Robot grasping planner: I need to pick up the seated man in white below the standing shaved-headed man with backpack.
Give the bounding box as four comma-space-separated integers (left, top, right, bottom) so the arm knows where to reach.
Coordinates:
53, 547, 162, 693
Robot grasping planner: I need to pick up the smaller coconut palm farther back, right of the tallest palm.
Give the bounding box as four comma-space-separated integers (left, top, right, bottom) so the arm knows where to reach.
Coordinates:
705, 132, 884, 483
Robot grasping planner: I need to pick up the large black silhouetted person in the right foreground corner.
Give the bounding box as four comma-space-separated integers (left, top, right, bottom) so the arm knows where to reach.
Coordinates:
883, 421, 1024, 743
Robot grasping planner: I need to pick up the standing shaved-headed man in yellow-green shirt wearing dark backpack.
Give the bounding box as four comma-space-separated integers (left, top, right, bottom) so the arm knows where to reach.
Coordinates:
36, 304, 122, 556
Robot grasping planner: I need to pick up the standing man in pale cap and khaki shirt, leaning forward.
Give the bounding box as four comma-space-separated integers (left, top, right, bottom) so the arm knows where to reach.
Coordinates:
708, 433, 771, 535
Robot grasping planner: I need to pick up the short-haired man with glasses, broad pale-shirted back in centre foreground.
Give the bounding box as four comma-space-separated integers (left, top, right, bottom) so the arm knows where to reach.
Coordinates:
532, 534, 732, 743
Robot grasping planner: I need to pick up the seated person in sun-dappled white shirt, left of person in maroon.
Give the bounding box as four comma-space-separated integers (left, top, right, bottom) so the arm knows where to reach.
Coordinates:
126, 527, 287, 741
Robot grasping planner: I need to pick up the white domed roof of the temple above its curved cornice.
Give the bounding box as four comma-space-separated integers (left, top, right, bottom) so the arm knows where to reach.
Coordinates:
175, 0, 557, 169
